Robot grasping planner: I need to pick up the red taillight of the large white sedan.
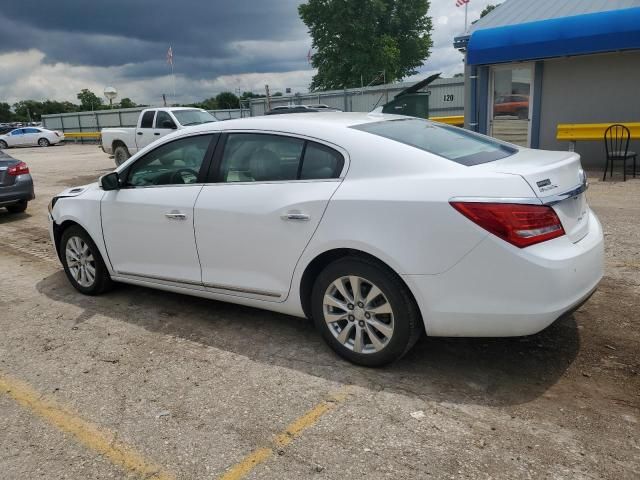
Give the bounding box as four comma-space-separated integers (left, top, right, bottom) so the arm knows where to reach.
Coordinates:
451, 202, 564, 248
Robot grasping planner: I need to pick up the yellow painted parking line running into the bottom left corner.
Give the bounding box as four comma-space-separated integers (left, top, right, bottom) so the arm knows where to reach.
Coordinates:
0, 372, 175, 480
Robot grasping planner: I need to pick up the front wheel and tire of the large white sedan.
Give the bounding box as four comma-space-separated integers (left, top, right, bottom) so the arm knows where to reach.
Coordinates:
60, 225, 113, 295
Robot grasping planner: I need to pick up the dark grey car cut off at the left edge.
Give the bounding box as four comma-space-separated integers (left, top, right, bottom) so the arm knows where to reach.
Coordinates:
0, 151, 36, 213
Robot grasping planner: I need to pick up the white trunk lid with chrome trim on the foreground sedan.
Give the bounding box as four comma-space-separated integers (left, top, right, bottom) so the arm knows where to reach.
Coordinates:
474, 149, 589, 243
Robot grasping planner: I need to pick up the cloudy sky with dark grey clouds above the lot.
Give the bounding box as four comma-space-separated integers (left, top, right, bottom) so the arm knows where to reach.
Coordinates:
0, 0, 495, 104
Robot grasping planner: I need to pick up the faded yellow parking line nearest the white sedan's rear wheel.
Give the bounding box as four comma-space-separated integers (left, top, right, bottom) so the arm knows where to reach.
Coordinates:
220, 389, 348, 480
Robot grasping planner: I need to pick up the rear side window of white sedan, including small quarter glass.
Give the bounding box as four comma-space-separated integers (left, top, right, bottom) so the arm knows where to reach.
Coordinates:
220, 133, 344, 183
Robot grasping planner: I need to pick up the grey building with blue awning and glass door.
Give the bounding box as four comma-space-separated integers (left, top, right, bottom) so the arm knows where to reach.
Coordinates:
454, 0, 640, 166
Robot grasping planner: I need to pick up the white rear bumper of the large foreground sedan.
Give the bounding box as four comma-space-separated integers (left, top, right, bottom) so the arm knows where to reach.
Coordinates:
403, 212, 604, 337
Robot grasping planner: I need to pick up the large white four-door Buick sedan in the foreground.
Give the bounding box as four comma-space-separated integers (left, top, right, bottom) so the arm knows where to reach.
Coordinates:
50, 113, 603, 366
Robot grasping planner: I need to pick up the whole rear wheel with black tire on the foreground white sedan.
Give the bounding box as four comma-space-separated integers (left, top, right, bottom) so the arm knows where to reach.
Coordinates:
311, 257, 423, 367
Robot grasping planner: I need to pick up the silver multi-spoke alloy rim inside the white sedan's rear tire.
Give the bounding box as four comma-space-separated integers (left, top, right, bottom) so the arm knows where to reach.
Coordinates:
323, 275, 394, 354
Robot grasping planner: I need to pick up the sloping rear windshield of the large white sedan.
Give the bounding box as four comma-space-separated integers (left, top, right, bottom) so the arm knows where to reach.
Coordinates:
351, 118, 518, 166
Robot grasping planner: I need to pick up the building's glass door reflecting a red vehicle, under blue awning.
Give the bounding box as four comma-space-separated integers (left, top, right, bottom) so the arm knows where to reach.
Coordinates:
489, 66, 533, 147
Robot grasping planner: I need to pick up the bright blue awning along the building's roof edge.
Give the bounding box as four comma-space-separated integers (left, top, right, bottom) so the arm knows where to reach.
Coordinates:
467, 7, 640, 65
